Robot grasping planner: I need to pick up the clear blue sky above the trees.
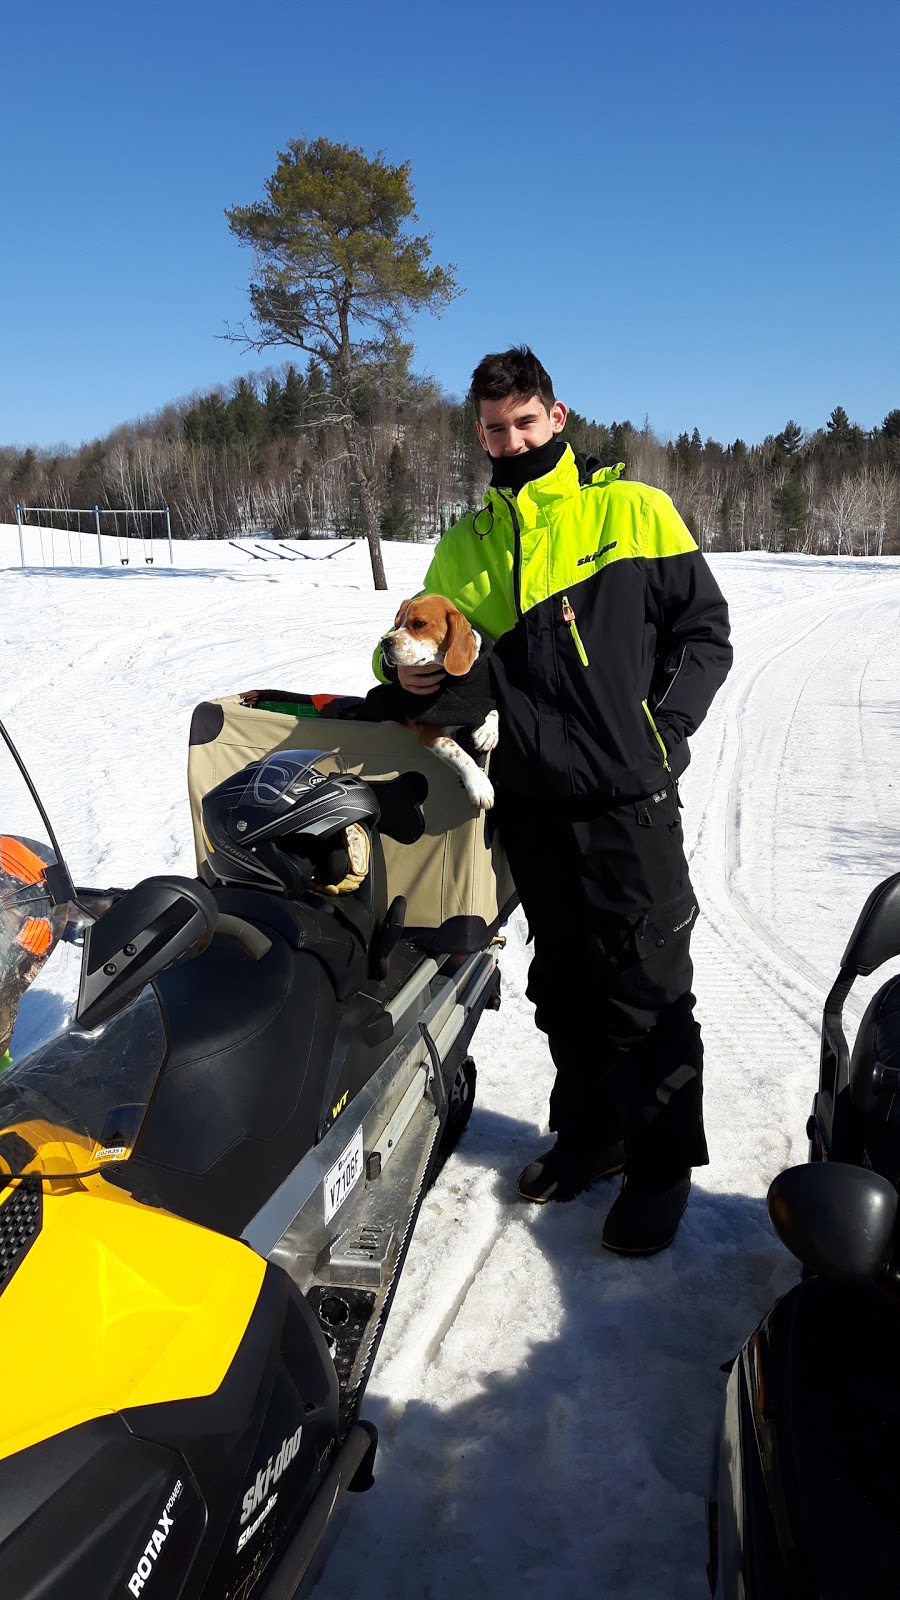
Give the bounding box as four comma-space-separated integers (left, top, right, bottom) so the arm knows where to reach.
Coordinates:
0, 0, 900, 445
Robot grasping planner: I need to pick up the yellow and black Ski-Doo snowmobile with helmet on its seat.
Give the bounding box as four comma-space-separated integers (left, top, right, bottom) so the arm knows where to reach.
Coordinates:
0, 730, 498, 1600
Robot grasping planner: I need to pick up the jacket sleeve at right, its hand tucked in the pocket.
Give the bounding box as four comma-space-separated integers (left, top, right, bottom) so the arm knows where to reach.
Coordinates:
647, 493, 732, 778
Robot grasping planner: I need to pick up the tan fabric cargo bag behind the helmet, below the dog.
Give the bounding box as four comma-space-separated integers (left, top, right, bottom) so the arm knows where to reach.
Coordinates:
187, 694, 516, 954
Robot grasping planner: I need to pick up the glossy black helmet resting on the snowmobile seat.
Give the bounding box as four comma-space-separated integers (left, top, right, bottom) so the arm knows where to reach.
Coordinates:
200, 750, 378, 894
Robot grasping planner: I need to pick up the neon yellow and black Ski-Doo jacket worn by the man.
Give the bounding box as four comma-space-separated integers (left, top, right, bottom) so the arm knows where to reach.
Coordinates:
375, 446, 732, 805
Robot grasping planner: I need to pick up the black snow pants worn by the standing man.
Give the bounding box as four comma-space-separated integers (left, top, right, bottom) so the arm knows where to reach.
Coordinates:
495, 779, 709, 1182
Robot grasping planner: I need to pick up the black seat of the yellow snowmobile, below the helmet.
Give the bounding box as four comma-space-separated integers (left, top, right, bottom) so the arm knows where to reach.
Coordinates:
110, 915, 339, 1237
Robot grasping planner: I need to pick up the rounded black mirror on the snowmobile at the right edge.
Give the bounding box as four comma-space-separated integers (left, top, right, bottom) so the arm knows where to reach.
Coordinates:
765, 1162, 897, 1283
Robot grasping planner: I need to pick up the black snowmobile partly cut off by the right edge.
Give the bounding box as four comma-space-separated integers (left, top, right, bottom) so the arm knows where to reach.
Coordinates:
709, 874, 900, 1600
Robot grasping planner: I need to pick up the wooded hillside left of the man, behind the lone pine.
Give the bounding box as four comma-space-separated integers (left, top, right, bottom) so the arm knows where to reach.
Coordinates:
0, 347, 487, 539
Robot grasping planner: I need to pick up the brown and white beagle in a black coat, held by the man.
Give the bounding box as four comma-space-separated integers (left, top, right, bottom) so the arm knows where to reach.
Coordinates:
375, 595, 498, 811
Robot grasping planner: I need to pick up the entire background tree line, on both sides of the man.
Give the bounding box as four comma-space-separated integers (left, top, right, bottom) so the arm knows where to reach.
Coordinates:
0, 372, 900, 555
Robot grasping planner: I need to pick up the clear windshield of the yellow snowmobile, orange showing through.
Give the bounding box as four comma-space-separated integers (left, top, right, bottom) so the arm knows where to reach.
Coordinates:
0, 730, 165, 1186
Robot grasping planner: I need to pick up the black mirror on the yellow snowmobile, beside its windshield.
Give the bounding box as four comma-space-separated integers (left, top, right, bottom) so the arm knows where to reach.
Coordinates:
75, 877, 218, 1027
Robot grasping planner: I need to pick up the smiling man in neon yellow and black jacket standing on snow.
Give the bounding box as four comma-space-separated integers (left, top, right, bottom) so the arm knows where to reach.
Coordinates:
371, 347, 732, 1254
